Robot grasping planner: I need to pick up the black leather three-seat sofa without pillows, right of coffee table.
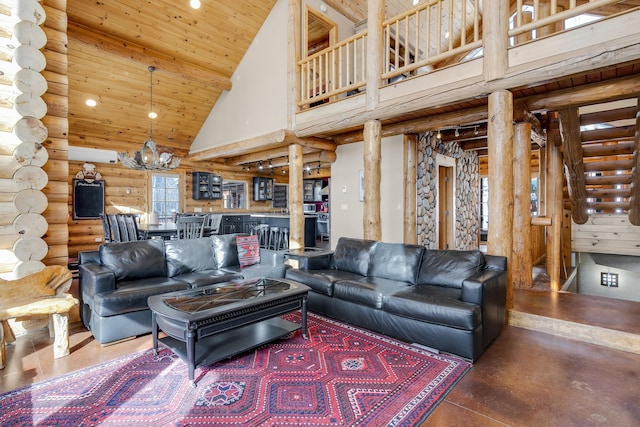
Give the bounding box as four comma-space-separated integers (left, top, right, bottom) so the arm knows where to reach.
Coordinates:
286, 237, 507, 361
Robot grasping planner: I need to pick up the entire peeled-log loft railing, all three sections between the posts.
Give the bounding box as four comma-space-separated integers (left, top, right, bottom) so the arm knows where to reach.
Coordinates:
298, 0, 638, 108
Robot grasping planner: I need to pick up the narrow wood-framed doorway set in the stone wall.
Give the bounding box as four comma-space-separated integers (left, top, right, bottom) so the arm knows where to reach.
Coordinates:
436, 156, 455, 249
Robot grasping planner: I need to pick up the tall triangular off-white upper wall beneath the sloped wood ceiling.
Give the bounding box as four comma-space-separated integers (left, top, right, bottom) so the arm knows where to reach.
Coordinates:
191, 0, 289, 153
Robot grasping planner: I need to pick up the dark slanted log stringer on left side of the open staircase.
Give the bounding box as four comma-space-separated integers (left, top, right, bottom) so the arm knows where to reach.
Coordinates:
558, 107, 589, 224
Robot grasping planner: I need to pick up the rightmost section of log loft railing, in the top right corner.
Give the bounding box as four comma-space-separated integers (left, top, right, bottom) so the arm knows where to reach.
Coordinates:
509, 0, 637, 44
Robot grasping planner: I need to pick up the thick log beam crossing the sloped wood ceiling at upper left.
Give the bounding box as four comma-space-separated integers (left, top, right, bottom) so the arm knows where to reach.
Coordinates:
68, 23, 231, 91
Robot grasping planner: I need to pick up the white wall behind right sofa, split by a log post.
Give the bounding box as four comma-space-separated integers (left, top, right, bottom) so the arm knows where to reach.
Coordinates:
330, 135, 404, 248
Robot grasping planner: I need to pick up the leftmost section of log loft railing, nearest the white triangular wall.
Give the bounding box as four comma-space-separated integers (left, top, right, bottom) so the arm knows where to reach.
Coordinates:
298, 31, 367, 105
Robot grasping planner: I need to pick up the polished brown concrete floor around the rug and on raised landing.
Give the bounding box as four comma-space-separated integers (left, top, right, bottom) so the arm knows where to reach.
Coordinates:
0, 284, 640, 427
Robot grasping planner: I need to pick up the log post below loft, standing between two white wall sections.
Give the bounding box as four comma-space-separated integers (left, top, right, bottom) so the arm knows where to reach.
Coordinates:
362, 120, 382, 240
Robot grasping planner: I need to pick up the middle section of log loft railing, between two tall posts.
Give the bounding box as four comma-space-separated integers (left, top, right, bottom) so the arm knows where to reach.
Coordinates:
382, 0, 482, 79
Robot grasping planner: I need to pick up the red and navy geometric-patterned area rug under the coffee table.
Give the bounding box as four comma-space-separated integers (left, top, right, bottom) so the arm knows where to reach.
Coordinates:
0, 313, 470, 427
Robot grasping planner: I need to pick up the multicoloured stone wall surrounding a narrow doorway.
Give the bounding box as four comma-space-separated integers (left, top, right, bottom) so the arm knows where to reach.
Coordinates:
417, 133, 480, 250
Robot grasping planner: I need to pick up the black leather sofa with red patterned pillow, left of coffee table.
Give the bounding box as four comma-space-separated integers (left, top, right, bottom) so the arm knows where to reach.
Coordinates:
78, 234, 288, 344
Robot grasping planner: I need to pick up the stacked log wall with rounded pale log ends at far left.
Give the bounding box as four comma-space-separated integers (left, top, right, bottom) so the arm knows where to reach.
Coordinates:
0, 0, 68, 278
